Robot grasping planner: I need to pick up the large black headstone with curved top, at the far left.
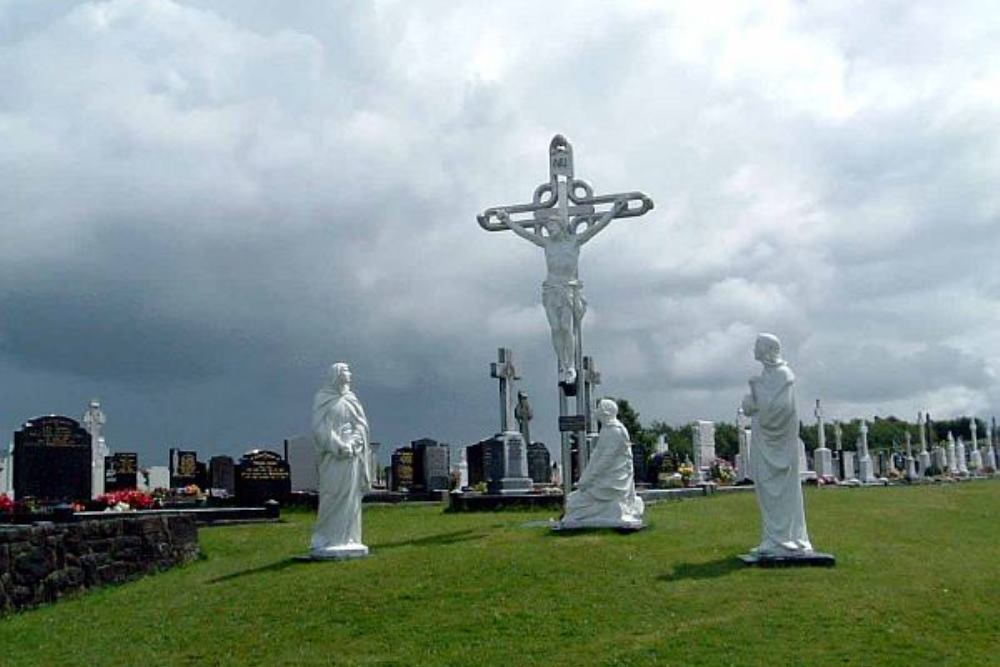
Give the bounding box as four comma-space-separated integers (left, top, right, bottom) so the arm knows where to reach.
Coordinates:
14, 415, 91, 502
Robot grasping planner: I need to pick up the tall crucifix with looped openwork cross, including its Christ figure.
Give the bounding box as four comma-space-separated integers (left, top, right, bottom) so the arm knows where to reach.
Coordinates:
477, 134, 653, 493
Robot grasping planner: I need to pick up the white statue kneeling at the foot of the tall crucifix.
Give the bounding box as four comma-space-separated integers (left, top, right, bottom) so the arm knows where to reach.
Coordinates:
553, 399, 644, 530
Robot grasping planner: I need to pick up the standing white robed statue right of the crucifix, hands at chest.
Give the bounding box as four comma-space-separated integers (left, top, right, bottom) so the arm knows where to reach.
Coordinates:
743, 333, 813, 558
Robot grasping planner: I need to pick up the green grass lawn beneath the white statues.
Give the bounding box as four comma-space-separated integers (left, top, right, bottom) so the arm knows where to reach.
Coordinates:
0, 481, 1000, 667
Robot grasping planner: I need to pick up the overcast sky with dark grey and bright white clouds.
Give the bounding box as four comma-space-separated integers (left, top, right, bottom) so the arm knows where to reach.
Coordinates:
0, 0, 1000, 465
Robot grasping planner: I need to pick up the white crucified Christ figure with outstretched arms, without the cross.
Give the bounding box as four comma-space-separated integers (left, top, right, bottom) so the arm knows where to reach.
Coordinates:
496, 199, 628, 385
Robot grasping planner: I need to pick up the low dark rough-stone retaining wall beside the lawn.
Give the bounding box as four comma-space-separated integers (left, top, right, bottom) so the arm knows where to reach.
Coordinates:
0, 516, 198, 615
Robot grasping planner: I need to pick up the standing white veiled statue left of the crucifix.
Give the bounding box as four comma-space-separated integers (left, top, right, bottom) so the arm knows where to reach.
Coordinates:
310, 363, 372, 559
